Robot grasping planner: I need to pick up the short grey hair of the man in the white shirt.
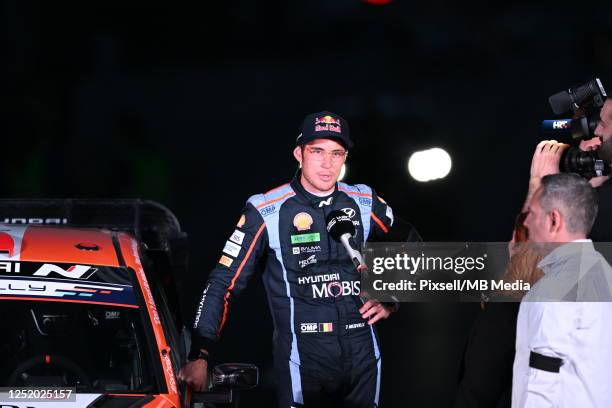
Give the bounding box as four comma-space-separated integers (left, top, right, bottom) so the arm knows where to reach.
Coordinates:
540, 173, 598, 235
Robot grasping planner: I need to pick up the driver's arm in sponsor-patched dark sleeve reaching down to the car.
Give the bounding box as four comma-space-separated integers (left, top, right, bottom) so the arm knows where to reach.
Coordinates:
179, 203, 267, 390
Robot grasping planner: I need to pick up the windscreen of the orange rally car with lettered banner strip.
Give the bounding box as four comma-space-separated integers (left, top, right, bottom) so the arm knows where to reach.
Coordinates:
0, 262, 159, 393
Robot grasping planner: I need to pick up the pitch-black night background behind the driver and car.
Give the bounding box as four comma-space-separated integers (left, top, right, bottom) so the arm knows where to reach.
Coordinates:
0, 0, 612, 407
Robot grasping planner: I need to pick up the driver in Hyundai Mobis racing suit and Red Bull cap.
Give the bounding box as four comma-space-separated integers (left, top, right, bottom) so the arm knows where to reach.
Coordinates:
180, 112, 420, 408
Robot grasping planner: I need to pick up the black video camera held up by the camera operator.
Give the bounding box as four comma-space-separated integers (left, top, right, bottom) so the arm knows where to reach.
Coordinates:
542, 78, 610, 179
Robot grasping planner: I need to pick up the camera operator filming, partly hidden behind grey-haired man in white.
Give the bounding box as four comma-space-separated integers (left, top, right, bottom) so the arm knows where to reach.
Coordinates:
454, 84, 612, 408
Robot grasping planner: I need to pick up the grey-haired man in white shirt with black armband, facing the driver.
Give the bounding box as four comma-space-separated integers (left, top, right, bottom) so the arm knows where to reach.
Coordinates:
512, 173, 612, 408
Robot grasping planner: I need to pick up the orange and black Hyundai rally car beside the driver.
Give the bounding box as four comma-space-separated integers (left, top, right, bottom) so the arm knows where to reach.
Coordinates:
0, 200, 256, 408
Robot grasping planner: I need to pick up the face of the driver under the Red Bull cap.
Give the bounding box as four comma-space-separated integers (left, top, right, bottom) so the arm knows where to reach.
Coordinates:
293, 139, 346, 193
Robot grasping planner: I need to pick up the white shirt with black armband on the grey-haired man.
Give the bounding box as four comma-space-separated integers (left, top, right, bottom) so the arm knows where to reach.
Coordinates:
512, 240, 612, 408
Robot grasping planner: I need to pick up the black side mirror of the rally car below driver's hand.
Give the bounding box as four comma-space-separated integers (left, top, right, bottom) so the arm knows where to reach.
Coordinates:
191, 363, 259, 408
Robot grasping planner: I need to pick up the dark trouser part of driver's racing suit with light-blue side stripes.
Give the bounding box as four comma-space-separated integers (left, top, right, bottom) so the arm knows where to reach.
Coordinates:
274, 325, 381, 408
